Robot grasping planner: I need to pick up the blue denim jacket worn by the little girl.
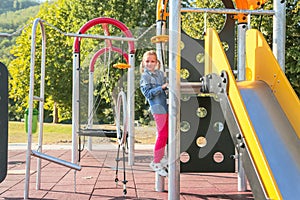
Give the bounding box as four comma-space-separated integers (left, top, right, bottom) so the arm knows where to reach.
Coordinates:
140, 69, 168, 114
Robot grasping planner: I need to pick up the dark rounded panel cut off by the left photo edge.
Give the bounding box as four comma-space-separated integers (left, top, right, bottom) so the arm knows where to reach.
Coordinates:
0, 62, 8, 183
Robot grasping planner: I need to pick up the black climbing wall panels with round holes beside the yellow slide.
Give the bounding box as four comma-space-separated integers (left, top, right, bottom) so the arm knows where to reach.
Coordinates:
180, 0, 235, 172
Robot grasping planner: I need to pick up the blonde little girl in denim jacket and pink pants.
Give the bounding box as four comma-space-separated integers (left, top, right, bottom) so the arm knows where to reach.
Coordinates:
140, 51, 168, 176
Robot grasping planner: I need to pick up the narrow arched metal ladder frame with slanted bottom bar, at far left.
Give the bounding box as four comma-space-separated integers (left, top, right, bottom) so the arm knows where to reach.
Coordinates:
24, 19, 81, 199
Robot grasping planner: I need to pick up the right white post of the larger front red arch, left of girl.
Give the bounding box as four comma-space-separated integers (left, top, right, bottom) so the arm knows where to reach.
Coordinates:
124, 53, 135, 165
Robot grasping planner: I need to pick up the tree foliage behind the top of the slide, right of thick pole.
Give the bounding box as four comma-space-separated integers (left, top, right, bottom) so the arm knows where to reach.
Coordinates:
182, 0, 300, 96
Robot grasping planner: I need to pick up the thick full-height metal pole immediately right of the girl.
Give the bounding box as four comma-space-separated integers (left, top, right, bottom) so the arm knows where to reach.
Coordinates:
168, 0, 181, 200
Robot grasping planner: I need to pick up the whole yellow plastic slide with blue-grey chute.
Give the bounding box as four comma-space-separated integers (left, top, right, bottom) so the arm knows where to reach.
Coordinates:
205, 29, 300, 199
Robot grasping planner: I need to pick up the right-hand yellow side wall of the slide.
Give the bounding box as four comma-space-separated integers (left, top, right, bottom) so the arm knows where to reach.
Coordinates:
246, 29, 300, 138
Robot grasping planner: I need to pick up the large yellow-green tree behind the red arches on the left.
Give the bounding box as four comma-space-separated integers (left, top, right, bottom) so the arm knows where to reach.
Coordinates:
9, 0, 155, 122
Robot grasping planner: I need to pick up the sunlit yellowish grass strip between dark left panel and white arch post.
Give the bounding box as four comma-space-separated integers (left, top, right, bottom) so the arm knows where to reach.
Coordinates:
8, 121, 72, 144
